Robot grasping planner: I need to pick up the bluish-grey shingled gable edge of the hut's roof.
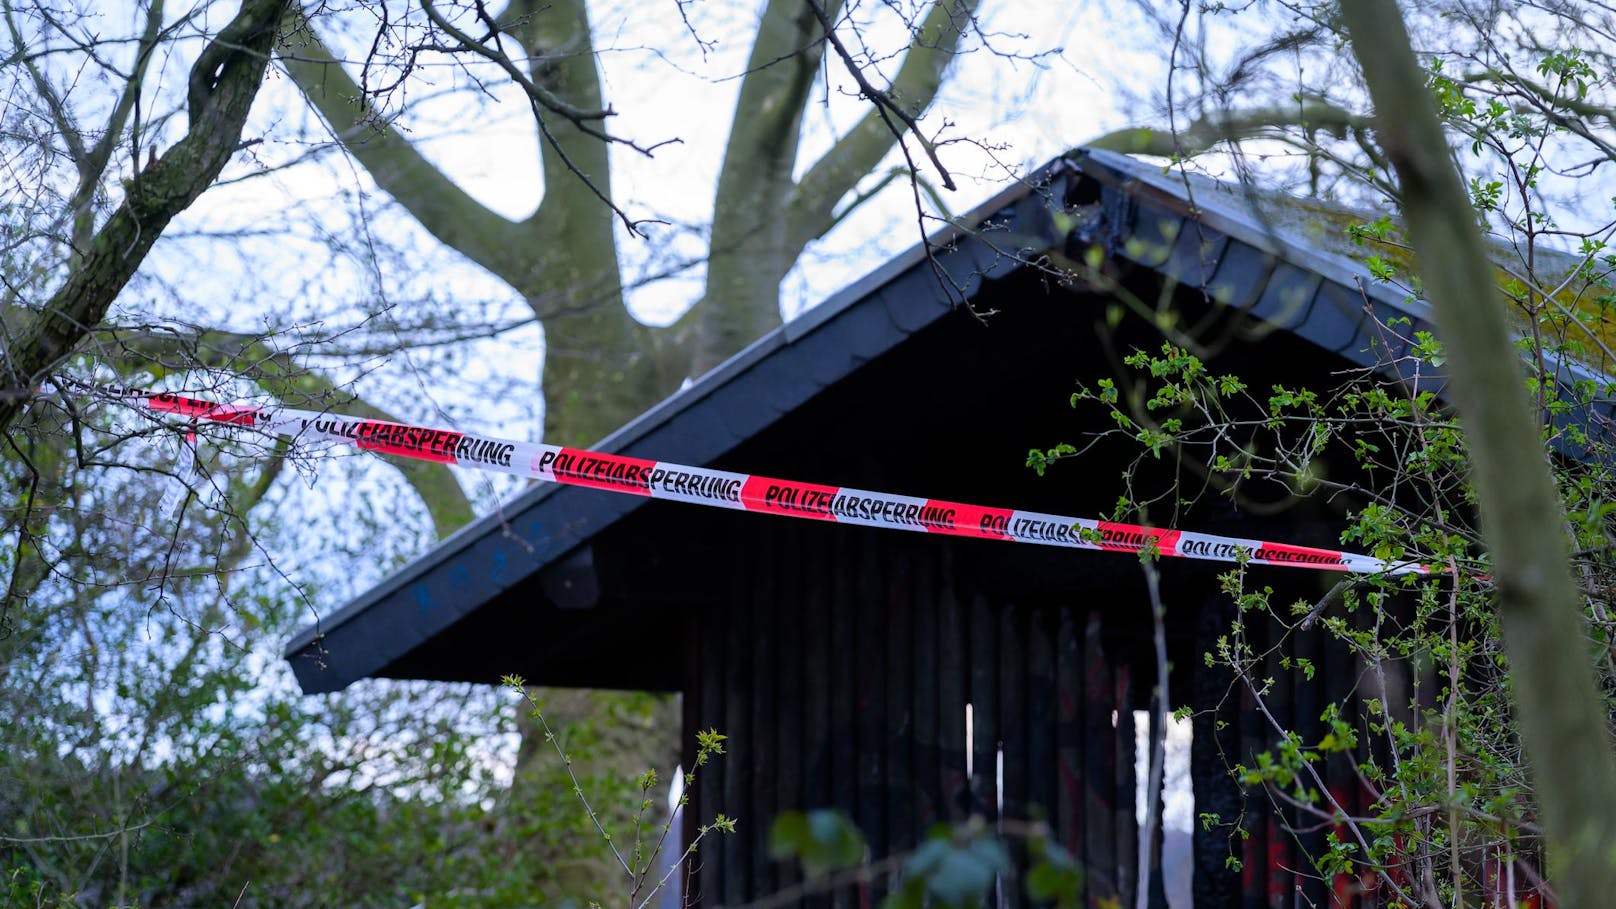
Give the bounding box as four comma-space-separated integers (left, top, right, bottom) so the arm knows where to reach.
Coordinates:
286, 144, 1593, 692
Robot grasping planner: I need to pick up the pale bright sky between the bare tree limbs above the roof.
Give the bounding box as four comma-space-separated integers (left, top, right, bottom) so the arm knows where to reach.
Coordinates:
120, 0, 1165, 530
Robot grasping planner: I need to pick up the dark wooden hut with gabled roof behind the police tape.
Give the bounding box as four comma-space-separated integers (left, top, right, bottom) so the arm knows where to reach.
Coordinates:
286, 152, 1603, 909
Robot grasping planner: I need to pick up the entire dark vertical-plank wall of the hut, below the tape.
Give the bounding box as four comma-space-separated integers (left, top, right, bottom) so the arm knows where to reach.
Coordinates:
669, 511, 1441, 909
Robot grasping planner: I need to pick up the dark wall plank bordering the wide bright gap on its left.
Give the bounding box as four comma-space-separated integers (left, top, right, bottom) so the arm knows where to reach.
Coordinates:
1083, 611, 1122, 906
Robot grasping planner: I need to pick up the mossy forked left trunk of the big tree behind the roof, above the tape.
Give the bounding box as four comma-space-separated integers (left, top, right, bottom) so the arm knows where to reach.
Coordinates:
280, 0, 669, 445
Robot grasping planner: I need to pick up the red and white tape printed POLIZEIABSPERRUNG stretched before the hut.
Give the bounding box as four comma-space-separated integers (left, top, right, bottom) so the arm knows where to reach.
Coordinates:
94, 385, 1433, 574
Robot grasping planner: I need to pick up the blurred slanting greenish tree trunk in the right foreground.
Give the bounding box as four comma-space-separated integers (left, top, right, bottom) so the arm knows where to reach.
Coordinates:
1343, 0, 1616, 892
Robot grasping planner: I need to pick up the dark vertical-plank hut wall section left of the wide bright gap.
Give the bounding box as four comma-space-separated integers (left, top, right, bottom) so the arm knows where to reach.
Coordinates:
685, 521, 1138, 906
